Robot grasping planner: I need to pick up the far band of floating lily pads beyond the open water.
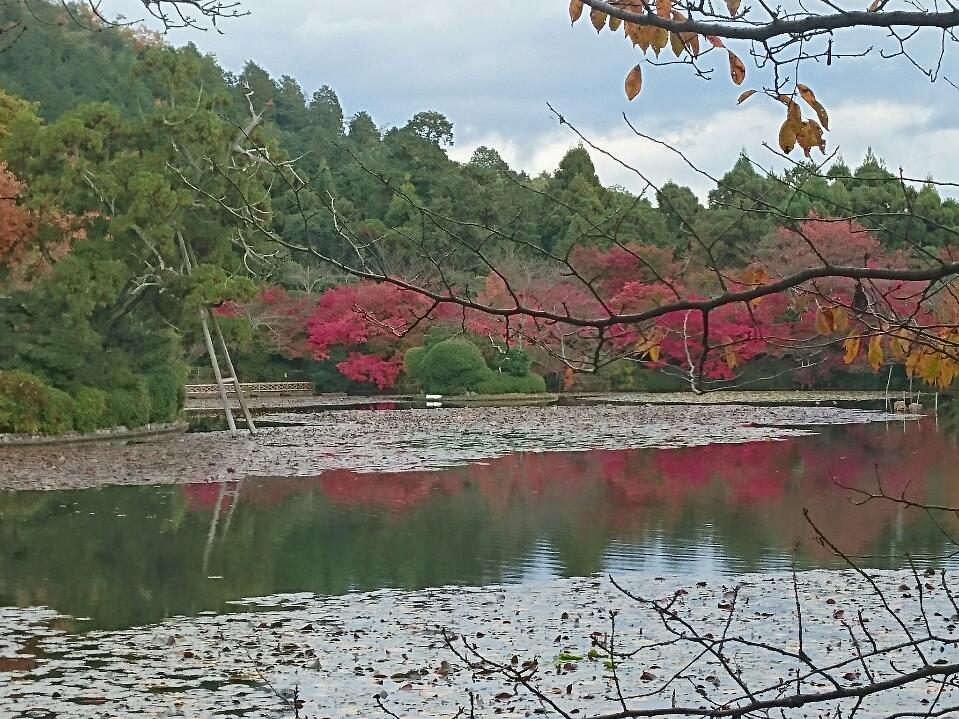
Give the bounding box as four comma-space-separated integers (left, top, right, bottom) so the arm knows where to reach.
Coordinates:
0, 403, 915, 490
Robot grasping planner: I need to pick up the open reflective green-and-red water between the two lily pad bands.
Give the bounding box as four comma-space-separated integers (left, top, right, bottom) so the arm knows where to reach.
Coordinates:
0, 422, 959, 628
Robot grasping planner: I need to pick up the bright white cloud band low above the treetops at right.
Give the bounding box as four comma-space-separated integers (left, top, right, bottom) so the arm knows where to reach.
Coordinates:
451, 98, 959, 198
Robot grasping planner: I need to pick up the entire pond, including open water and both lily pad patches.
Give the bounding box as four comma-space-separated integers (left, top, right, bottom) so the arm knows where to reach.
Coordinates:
0, 404, 959, 719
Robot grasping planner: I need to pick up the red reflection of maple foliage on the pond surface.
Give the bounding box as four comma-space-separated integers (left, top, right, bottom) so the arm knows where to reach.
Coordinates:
184, 424, 959, 554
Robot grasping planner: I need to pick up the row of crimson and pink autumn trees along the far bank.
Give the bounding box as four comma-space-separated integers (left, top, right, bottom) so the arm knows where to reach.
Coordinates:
227, 215, 959, 389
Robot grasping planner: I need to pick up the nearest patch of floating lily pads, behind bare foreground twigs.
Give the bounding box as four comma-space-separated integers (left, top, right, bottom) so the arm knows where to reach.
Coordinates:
0, 570, 959, 719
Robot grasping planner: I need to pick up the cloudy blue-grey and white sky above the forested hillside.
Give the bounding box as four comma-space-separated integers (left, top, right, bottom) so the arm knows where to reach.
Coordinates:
144, 0, 959, 197
